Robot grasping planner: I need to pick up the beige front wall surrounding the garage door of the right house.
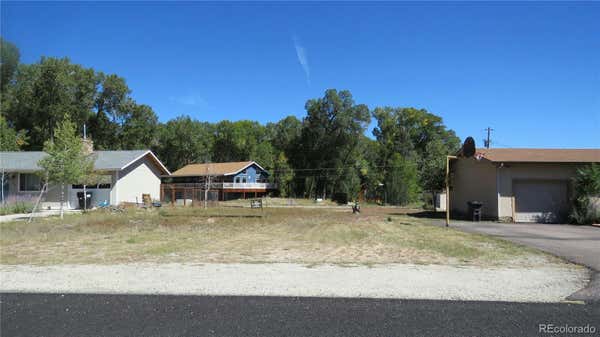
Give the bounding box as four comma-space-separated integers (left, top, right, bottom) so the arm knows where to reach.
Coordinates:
498, 163, 578, 218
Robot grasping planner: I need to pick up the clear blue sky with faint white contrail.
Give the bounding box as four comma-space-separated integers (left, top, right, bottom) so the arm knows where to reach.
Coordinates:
1, 1, 600, 148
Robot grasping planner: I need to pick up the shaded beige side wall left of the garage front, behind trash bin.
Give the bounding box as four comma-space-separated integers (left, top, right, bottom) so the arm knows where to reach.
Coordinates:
450, 158, 498, 218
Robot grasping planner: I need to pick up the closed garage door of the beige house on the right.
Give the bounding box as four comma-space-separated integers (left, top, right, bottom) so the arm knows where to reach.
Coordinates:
513, 180, 568, 222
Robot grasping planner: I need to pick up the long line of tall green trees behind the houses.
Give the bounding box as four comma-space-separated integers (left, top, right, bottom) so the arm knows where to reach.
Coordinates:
0, 40, 460, 204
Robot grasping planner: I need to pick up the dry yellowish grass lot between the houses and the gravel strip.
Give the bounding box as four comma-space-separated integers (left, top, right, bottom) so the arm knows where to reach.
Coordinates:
0, 203, 557, 266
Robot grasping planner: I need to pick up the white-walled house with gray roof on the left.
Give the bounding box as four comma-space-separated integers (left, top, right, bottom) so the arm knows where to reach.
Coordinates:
0, 150, 170, 209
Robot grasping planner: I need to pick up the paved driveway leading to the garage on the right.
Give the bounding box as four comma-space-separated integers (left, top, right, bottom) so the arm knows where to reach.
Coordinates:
442, 221, 600, 301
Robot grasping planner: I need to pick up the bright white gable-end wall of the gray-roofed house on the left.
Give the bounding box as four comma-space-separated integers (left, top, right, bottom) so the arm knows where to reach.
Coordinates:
113, 158, 160, 203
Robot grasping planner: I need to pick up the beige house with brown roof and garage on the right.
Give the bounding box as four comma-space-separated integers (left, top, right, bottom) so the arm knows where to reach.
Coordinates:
450, 148, 600, 222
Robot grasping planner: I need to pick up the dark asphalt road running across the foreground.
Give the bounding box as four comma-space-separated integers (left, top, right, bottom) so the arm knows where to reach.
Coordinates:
0, 289, 600, 337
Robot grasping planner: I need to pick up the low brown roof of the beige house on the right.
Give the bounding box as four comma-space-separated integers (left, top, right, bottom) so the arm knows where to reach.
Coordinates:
475, 148, 600, 163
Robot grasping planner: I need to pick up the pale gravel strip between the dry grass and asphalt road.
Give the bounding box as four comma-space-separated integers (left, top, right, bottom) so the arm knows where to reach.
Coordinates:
0, 263, 589, 302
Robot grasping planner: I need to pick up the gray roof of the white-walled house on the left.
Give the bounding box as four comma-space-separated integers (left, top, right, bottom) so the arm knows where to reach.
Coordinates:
0, 150, 169, 174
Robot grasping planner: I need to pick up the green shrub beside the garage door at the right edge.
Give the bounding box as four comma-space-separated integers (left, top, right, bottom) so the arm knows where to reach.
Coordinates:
570, 164, 600, 225
